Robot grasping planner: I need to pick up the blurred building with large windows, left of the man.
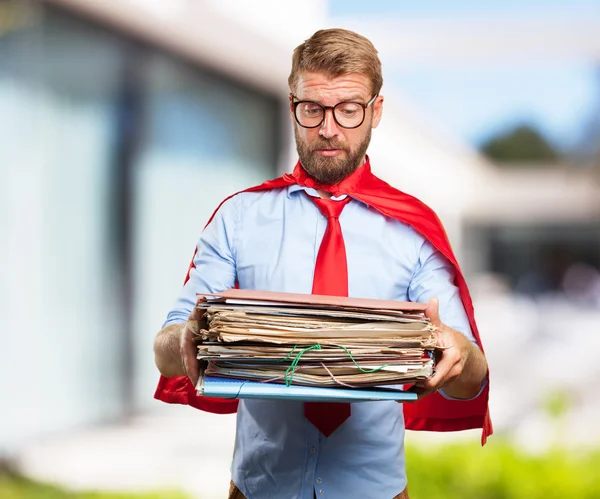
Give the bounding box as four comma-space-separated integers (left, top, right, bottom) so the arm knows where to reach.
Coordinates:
0, 0, 309, 453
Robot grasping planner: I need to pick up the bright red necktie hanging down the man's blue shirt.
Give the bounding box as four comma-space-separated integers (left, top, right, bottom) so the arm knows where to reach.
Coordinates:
304, 196, 351, 437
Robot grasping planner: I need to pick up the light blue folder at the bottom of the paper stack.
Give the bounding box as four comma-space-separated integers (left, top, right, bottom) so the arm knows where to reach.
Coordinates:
198, 376, 417, 402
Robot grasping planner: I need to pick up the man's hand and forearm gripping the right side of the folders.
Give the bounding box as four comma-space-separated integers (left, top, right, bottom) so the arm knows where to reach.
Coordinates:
410, 298, 487, 399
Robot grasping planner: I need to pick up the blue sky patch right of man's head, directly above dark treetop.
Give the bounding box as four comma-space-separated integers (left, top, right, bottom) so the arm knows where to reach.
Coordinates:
386, 62, 600, 147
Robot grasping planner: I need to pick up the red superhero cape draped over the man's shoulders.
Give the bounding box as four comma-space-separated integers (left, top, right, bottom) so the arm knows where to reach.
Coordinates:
154, 158, 493, 444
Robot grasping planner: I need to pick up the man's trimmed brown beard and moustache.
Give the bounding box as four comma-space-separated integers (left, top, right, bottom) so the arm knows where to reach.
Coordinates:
294, 123, 371, 185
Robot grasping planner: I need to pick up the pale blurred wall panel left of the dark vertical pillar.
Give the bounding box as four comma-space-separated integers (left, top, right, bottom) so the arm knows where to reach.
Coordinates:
0, 30, 122, 453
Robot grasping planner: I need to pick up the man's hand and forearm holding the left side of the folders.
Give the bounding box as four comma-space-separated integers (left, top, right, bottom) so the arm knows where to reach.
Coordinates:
154, 298, 203, 386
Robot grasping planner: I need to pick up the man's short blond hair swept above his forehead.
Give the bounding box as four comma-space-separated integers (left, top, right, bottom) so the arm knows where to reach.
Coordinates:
288, 29, 383, 95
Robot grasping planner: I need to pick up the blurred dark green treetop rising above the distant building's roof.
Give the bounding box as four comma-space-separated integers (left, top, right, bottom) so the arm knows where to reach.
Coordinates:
481, 125, 559, 163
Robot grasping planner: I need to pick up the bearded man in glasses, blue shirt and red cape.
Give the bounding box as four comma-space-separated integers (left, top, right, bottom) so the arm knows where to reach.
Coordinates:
155, 29, 491, 499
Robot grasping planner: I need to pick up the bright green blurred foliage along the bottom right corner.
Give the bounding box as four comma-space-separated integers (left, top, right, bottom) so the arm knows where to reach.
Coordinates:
406, 437, 600, 499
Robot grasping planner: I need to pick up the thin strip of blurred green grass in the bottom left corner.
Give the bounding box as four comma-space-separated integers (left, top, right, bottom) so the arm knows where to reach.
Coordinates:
0, 473, 189, 499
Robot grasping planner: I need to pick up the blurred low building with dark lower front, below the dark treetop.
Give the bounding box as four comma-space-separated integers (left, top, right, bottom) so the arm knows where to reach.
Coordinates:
463, 164, 600, 294
